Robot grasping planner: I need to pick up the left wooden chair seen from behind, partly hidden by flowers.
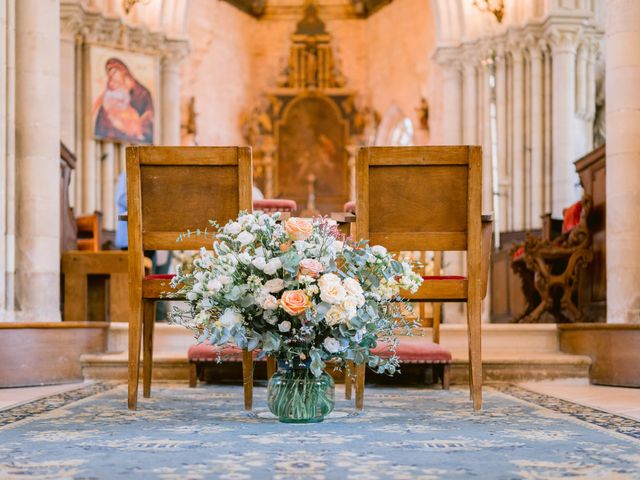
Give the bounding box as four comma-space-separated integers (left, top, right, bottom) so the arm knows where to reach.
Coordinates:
127, 146, 253, 410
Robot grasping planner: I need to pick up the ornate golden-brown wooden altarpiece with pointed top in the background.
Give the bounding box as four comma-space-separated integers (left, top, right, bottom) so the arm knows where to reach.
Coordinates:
242, 4, 375, 215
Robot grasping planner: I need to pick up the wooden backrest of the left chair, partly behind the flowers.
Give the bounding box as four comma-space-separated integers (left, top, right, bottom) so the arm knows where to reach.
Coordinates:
127, 146, 252, 255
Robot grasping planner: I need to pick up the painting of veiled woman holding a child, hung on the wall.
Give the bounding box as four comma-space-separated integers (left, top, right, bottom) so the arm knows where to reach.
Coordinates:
89, 46, 157, 145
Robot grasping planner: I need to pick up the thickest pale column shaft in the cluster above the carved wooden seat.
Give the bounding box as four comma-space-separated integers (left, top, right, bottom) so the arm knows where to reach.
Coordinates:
549, 28, 580, 218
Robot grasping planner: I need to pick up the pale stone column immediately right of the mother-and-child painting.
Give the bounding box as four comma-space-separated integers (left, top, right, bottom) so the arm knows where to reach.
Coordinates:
161, 40, 187, 145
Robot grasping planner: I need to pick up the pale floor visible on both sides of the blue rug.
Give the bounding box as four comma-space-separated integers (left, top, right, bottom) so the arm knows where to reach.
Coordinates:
0, 378, 640, 420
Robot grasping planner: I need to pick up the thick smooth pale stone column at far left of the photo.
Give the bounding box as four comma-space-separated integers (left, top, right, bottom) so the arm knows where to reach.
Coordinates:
16, 0, 60, 321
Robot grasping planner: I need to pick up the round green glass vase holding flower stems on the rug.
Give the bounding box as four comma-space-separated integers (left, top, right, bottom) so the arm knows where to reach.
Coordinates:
267, 360, 335, 423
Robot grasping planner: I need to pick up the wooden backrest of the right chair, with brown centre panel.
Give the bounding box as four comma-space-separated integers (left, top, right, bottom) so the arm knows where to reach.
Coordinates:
356, 146, 482, 261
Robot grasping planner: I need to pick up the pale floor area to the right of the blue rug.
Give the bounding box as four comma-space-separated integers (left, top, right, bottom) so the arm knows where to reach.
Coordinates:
519, 378, 640, 420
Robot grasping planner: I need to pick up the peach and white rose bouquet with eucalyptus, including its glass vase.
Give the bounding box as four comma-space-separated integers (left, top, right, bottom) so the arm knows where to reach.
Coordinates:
171, 212, 422, 422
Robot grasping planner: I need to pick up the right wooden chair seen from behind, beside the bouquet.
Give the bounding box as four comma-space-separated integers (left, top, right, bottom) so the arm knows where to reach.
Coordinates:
355, 146, 491, 410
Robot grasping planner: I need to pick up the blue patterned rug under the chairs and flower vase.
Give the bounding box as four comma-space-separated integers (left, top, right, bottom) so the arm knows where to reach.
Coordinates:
0, 383, 640, 480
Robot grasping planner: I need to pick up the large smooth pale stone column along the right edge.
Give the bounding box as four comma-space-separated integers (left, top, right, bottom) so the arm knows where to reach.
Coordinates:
605, 0, 640, 323
